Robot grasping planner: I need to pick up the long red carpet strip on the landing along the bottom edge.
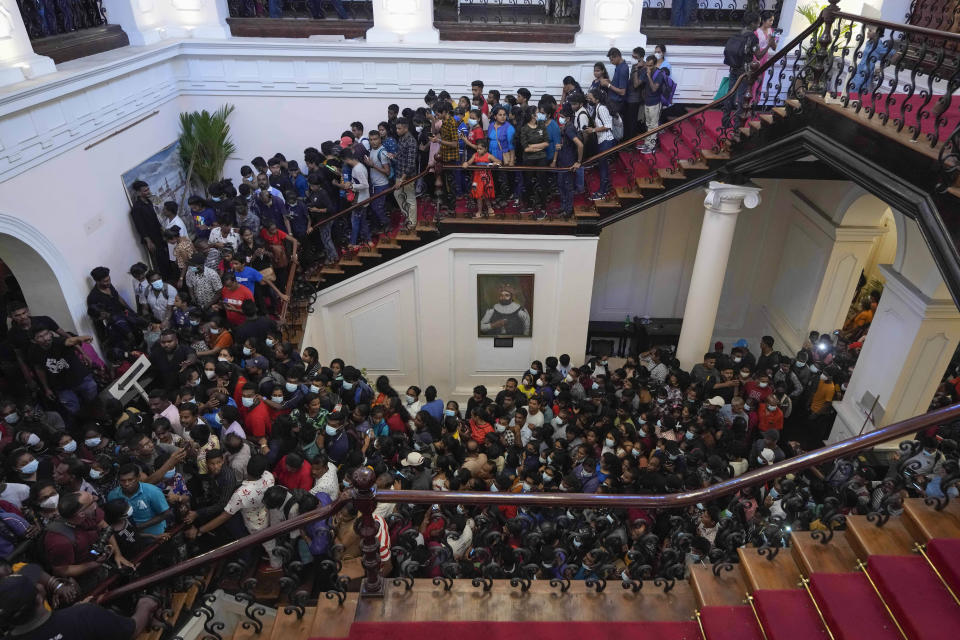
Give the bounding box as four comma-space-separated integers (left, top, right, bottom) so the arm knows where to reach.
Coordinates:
313, 622, 701, 640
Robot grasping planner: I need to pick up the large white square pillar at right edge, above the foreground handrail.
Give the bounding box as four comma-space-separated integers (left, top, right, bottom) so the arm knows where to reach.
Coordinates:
830, 265, 960, 442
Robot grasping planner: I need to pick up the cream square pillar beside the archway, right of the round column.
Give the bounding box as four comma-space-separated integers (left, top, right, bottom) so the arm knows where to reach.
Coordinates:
807, 227, 886, 332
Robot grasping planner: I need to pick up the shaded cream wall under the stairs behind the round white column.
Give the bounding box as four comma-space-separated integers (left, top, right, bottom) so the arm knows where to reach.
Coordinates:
590, 180, 896, 352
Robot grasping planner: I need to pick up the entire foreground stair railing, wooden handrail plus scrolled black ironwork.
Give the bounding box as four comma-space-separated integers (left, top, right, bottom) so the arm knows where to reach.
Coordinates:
99, 398, 960, 638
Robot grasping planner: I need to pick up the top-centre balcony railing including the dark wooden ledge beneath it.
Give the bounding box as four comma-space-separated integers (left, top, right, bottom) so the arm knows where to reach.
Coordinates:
433, 0, 581, 42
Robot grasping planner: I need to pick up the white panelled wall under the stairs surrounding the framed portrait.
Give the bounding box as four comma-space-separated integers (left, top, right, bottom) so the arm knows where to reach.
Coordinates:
303, 234, 597, 399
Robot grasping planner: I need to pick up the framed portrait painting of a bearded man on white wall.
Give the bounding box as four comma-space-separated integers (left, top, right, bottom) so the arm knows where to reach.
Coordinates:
477, 273, 533, 338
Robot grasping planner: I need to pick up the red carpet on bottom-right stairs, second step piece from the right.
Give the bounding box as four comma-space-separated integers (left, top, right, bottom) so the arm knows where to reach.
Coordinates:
867, 556, 960, 640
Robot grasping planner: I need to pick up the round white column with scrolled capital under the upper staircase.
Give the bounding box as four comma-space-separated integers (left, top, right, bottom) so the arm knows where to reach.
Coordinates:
677, 182, 760, 369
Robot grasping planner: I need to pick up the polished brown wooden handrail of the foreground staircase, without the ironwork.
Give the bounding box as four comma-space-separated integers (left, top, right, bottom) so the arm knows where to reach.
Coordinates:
98, 404, 960, 602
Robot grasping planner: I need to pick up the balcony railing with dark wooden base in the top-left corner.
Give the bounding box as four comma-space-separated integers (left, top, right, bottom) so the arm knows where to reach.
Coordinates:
17, 0, 130, 63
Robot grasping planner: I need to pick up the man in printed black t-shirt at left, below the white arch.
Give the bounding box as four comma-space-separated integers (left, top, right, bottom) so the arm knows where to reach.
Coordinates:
28, 327, 97, 414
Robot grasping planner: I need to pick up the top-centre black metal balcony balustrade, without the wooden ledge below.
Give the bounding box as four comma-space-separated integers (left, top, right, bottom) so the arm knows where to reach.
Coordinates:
433, 0, 581, 27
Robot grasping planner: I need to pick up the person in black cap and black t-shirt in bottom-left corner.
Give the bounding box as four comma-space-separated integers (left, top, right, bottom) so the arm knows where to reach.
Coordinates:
0, 574, 158, 640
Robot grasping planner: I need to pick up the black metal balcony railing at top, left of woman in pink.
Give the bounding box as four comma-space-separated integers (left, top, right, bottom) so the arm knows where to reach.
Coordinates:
643, 0, 783, 30
